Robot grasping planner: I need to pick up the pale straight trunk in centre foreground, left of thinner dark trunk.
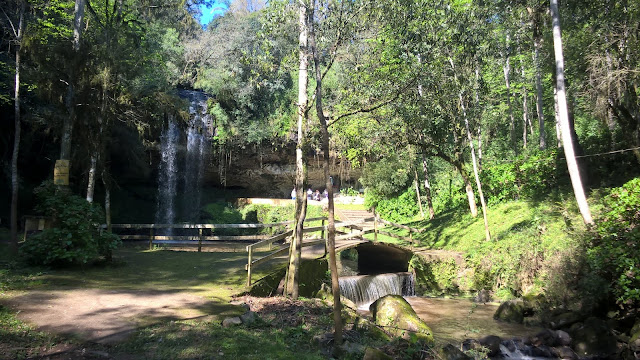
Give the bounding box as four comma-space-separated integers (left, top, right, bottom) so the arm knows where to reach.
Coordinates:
285, 1, 309, 299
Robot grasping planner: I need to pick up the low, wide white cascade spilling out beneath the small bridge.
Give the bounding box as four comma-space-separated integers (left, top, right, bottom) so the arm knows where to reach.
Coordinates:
339, 272, 415, 307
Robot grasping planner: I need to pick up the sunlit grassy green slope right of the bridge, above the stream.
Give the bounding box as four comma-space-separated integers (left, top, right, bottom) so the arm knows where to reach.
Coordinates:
367, 198, 601, 298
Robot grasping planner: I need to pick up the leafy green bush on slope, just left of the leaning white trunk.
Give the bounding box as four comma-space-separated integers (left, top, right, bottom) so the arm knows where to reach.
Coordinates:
481, 149, 561, 203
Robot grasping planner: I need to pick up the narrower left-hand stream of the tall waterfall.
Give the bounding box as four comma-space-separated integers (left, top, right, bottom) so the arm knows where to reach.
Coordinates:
155, 116, 180, 234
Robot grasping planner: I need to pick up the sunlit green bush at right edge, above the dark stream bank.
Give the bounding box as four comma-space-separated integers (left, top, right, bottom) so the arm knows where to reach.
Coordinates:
587, 178, 640, 305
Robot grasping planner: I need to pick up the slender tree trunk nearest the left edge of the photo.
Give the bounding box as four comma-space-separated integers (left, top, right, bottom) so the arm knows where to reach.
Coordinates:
10, 0, 26, 254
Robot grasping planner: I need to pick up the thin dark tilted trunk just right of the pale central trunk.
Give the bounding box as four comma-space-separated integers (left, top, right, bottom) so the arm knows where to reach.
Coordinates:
308, 4, 342, 348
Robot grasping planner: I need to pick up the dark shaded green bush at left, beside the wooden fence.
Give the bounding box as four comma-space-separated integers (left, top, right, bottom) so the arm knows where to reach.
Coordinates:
20, 182, 120, 266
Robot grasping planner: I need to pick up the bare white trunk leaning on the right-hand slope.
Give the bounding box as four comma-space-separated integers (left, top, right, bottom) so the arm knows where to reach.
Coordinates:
550, 0, 593, 225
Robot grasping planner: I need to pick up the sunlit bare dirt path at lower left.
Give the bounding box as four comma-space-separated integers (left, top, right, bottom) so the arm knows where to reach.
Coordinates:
2, 289, 220, 343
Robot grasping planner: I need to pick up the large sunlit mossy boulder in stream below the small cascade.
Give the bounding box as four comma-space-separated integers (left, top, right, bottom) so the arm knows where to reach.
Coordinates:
369, 295, 433, 345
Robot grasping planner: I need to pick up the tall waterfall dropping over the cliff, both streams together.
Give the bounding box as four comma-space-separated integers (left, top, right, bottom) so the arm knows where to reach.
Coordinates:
155, 90, 212, 231
